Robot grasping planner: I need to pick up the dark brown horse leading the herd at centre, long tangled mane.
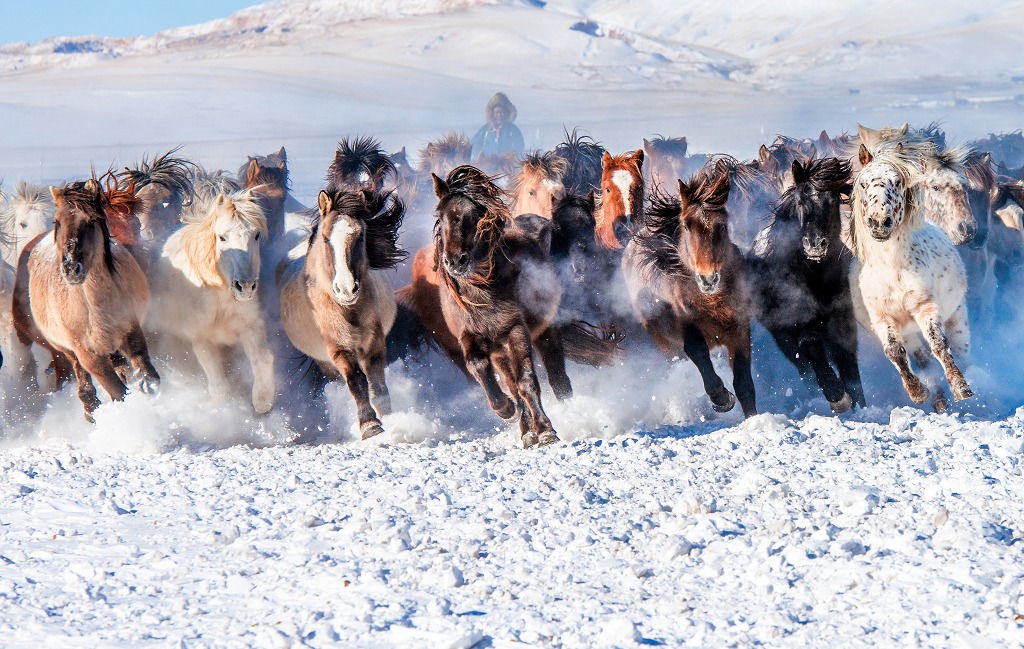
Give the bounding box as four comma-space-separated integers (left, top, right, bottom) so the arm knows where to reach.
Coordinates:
434, 166, 572, 447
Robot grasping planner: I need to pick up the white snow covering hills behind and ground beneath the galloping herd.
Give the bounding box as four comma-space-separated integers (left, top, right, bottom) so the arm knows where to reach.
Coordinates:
0, 0, 1024, 649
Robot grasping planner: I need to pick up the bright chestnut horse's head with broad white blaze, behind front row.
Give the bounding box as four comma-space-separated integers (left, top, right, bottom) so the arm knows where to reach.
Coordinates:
594, 149, 644, 250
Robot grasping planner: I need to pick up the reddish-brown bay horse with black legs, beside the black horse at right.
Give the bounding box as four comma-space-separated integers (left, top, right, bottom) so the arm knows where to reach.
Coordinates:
623, 162, 757, 417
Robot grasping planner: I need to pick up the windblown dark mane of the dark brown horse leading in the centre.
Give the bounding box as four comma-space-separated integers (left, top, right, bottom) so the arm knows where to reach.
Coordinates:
434, 165, 512, 310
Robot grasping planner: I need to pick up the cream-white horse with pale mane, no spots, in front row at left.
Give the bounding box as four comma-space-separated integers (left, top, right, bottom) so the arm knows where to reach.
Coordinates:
146, 185, 275, 414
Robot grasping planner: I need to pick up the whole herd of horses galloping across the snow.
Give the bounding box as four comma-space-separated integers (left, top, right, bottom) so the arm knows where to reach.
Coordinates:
0, 125, 1024, 447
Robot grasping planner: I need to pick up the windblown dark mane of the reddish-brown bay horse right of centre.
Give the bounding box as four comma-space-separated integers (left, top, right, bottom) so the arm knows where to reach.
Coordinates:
633, 160, 730, 279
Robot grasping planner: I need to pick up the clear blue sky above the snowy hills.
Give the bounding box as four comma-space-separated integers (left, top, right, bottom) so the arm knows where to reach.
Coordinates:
0, 0, 259, 43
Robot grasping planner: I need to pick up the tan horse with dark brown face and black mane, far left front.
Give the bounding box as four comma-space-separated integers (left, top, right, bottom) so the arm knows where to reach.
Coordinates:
28, 180, 160, 421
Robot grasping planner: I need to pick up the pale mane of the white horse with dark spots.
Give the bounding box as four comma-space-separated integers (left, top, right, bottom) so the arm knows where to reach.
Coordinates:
850, 141, 934, 261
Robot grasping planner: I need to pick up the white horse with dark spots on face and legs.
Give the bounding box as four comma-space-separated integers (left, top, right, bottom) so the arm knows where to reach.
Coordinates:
850, 142, 973, 412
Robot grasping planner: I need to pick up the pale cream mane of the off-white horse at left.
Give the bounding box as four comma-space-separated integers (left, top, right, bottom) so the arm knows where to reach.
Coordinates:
178, 183, 267, 289
